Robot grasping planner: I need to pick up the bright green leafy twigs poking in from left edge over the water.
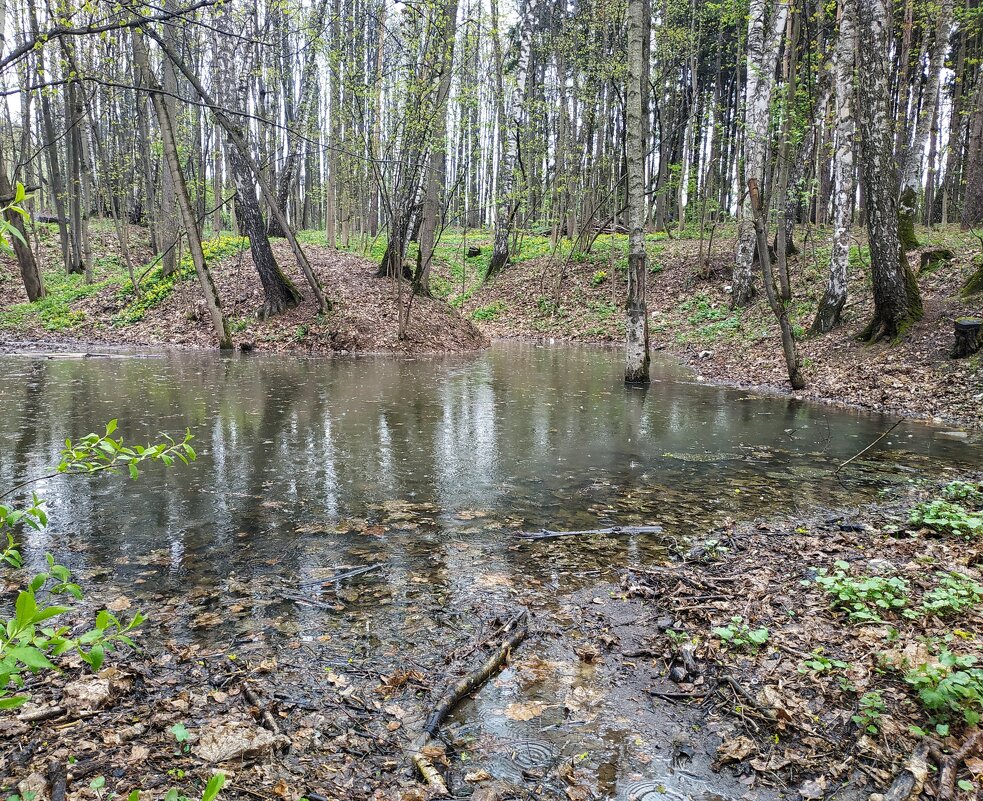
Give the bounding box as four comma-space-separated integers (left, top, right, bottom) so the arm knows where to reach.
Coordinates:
0, 420, 197, 709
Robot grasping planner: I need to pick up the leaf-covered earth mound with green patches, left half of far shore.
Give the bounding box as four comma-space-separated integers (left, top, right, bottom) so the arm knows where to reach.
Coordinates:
0, 229, 488, 355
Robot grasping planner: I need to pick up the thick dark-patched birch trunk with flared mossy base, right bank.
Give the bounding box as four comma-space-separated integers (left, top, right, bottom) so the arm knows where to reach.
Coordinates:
857, 0, 922, 342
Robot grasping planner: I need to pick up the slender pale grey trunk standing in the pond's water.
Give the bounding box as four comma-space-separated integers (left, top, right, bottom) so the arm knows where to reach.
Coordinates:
625, 0, 650, 384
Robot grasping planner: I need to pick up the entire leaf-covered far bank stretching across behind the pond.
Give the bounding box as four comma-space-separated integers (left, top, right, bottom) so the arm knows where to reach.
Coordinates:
0, 224, 983, 426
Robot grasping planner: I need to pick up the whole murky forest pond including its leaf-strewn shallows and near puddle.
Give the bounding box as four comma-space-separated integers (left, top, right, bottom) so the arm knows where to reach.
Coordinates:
0, 344, 983, 799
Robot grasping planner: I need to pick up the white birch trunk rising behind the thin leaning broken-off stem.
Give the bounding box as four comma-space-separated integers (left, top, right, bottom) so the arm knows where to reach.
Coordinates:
731, 0, 788, 308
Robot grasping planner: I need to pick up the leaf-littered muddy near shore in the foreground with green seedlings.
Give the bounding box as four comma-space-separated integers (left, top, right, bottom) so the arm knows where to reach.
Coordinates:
0, 475, 983, 801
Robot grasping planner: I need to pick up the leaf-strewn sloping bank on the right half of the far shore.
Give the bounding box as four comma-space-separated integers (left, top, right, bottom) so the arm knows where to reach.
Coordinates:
464, 231, 983, 426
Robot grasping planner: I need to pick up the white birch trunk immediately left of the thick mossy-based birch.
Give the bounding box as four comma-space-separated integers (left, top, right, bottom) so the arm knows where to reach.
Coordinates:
812, 0, 857, 334
